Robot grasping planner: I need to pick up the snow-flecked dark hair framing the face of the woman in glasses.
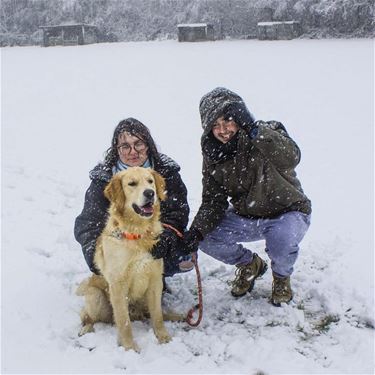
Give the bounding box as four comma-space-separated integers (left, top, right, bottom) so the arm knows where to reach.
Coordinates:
104, 117, 159, 168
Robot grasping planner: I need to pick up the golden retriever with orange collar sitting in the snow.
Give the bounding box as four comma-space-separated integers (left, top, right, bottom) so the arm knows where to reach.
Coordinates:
77, 167, 175, 352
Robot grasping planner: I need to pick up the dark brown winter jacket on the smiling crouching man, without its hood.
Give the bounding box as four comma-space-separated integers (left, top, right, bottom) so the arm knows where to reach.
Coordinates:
192, 121, 311, 236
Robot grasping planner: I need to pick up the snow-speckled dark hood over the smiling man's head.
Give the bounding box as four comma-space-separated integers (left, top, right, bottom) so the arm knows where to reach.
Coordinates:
199, 87, 244, 140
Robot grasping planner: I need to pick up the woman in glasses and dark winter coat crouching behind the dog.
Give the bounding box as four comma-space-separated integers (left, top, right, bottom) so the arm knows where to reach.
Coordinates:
74, 118, 194, 288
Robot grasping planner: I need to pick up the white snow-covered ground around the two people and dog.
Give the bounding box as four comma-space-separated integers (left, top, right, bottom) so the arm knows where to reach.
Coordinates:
1, 40, 374, 374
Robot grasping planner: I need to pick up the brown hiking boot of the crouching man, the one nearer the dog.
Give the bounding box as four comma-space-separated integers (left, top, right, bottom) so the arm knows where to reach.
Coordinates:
231, 253, 268, 297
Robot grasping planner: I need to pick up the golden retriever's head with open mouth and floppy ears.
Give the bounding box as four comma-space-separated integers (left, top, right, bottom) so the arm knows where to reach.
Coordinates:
104, 167, 165, 219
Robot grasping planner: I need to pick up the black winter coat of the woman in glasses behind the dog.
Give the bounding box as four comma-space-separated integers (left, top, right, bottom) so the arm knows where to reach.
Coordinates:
74, 154, 189, 273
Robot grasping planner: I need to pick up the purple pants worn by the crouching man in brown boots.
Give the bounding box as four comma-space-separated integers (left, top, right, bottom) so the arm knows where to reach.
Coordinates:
199, 209, 310, 277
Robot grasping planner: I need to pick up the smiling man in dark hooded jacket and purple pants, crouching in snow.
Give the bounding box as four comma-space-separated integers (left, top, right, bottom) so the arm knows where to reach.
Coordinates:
184, 87, 311, 306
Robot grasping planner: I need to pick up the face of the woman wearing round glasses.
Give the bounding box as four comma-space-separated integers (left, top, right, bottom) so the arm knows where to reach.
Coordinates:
117, 132, 148, 167
